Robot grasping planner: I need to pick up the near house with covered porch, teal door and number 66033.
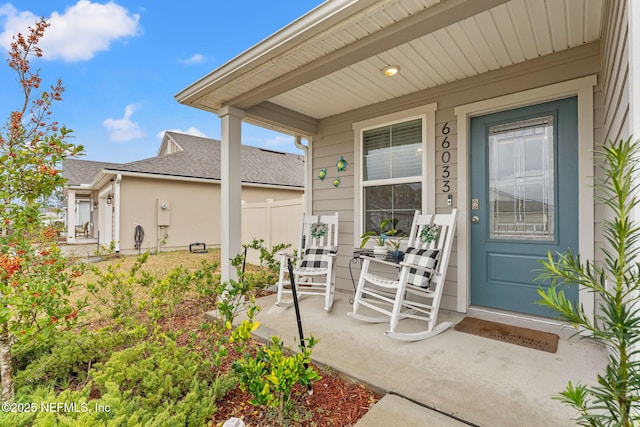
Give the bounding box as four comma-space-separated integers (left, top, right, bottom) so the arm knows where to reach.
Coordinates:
176, 0, 640, 325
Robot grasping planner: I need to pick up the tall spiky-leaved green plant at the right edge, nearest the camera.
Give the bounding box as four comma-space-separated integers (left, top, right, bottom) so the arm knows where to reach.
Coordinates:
538, 139, 640, 427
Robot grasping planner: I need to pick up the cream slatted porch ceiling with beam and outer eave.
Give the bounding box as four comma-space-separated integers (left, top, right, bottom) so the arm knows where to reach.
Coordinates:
176, 0, 604, 134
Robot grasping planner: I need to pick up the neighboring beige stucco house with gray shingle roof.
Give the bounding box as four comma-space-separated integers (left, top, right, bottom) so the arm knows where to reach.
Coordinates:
63, 132, 304, 252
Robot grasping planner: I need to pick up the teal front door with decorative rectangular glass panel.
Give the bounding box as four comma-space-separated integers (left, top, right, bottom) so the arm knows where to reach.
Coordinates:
469, 98, 578, 317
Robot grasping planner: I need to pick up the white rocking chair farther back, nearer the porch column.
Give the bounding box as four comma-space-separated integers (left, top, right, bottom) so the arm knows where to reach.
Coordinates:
276, 212, 338, 311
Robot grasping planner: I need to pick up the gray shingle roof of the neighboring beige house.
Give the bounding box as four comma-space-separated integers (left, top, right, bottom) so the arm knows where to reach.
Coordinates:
63, 132, 304, 187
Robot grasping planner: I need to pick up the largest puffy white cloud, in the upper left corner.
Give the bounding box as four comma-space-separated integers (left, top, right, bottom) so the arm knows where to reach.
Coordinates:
0, 0, 140, 62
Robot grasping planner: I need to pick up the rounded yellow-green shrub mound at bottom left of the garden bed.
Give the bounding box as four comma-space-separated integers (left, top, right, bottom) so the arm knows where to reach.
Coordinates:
87, 338, 226, 426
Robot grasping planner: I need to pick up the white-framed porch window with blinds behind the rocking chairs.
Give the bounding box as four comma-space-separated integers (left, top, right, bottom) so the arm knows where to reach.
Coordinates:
362, 119, 423, 234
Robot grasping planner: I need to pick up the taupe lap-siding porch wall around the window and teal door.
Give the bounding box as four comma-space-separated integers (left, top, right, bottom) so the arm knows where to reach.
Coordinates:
311, 43, 600, 309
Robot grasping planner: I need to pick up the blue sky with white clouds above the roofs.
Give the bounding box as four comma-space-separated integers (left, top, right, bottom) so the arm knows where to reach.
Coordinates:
0, 0, 322, 163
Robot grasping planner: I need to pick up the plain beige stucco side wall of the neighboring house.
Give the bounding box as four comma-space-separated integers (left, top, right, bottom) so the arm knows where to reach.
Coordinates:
120, 176, 303, 253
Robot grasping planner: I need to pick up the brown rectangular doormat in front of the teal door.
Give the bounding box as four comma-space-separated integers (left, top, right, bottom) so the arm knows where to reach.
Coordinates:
454, 317, 558, 353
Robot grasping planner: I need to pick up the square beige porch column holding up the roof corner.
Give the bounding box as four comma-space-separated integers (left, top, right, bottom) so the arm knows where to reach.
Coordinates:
218, 106, 244, 282
